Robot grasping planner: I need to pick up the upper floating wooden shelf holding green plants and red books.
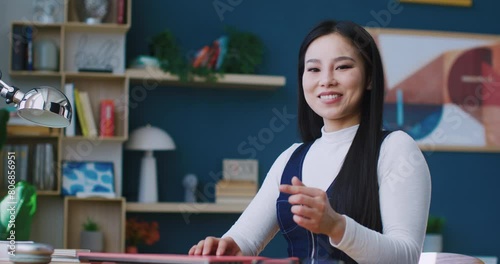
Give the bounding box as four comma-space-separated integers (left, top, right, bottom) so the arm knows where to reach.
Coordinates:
126, 68, 286, 90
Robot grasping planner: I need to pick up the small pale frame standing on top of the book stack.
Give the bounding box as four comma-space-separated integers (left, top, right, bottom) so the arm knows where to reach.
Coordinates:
222, 159, 259, 182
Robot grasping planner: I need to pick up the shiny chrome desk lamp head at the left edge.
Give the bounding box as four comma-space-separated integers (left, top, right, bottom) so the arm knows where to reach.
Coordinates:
0, 71, 72, 128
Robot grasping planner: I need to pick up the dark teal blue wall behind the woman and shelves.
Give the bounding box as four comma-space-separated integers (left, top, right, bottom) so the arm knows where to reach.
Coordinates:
123, 0, 500, 257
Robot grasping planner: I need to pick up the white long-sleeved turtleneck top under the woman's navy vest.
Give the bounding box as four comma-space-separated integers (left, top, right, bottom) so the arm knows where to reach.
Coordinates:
223, 125, 431, 264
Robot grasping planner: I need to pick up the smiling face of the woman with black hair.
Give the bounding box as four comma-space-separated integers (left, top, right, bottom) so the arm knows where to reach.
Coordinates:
302, 33, 367, 132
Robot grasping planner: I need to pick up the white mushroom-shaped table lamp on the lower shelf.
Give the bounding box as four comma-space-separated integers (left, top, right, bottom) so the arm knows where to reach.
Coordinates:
126, 125, 175, 203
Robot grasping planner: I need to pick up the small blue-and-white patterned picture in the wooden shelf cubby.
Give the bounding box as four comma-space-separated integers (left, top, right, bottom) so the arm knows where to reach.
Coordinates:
62, 161, 115, 197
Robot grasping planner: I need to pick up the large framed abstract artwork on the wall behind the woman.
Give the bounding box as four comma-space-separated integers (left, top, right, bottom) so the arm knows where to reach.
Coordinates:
368, 29, 500, 151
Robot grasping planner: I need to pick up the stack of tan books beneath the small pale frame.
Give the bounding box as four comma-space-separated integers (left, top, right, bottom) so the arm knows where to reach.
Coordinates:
215, 180, 257, 204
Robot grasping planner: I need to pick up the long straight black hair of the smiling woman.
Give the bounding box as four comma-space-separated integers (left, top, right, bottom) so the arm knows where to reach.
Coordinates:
298, 20, 385, 232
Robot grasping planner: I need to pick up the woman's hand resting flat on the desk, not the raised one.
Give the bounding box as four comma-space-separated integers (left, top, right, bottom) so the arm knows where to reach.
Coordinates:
188, 237, 243, 256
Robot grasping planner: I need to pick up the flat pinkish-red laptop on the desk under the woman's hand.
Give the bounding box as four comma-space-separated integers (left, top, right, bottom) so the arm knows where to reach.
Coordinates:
78, 252, 299, 264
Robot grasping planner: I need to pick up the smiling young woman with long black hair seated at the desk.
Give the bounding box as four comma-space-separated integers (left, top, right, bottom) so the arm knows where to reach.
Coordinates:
189, 21, 431, 263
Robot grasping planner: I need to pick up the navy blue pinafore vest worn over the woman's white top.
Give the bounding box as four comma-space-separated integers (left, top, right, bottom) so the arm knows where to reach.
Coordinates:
276, 131, 390, 264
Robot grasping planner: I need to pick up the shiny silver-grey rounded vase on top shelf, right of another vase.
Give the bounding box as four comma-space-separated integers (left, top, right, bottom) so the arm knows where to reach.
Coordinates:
75, 0, 109, 24
